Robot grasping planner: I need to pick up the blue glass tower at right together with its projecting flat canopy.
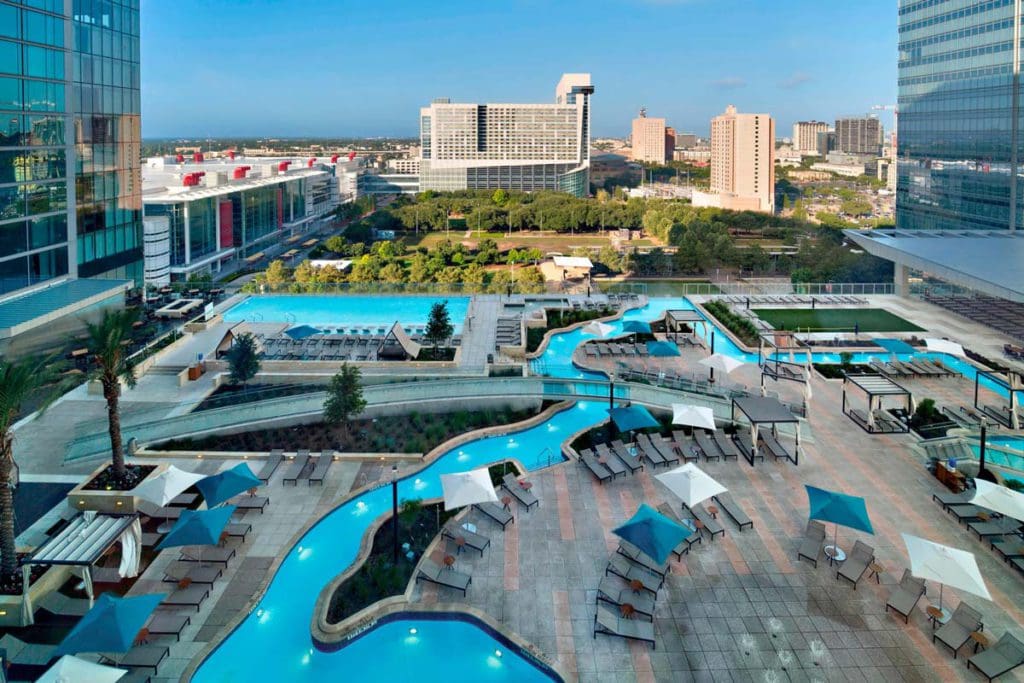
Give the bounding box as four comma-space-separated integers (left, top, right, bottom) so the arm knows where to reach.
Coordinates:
849, 0, 1024, 301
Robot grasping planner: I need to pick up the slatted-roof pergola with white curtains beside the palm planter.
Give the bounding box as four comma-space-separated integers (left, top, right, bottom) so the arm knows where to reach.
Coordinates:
22, 511, 142, 624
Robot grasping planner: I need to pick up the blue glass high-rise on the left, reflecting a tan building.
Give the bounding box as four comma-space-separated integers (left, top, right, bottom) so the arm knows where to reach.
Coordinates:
0, 0, 142, 344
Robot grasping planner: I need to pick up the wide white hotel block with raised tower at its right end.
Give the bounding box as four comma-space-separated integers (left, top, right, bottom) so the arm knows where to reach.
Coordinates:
419, 74, 593, 197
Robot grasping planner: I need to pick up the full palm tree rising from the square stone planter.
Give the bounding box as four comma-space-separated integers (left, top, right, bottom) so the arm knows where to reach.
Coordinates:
86, 308, 138, 485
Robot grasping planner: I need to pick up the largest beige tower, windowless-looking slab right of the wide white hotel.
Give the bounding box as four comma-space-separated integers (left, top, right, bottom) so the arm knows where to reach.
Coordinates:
711, 104, 775, 213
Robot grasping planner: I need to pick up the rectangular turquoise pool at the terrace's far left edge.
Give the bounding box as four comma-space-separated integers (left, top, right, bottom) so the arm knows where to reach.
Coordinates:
224, 294, 470, 334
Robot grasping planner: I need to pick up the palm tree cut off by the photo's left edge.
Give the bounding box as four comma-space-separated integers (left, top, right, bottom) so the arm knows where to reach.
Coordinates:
0, 358, 61, 584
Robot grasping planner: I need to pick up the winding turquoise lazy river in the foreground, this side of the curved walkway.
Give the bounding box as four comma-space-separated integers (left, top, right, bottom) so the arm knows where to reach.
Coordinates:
193, 401, 607, 683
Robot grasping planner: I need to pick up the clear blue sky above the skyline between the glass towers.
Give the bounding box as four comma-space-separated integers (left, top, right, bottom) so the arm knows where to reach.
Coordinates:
141, 0, 896, 137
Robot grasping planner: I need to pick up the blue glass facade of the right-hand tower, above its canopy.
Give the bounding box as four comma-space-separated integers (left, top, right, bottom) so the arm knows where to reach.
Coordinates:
896, 0, 1024, 229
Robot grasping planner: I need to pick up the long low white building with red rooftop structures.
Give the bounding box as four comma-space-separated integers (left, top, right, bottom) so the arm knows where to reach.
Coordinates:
142, 154, 339, 285
